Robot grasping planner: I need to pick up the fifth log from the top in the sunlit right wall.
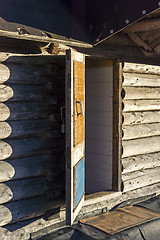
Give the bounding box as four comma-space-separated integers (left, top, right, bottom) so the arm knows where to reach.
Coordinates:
123, 111, 160, 125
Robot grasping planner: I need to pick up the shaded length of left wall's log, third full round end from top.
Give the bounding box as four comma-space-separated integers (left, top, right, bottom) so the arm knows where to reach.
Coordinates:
5, 102, 57, 120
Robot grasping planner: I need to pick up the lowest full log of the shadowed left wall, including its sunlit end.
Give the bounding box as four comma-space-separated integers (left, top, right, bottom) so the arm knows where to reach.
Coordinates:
0, 196, 63, 226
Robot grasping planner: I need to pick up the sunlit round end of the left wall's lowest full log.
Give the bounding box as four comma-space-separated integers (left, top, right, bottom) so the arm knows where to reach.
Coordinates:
0, 205, 12, 226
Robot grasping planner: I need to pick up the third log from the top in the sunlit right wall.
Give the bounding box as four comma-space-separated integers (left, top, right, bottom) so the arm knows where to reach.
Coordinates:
123, 87, 160, 100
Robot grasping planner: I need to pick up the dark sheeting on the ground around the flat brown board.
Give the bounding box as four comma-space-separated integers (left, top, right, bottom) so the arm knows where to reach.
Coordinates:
31, 195, 160, 240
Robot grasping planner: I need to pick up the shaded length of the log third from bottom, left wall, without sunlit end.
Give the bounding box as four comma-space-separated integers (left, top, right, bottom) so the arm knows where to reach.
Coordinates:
5, 156, 65, 180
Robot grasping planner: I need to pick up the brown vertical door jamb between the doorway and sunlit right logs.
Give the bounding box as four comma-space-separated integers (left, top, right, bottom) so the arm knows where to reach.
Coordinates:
112, 61, 122, 191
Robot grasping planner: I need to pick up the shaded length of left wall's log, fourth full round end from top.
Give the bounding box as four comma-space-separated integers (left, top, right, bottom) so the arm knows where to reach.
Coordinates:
6, 119, 61, 139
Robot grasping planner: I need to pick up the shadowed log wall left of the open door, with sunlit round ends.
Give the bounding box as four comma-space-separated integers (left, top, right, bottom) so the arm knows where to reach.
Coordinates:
0, 53, 65, 226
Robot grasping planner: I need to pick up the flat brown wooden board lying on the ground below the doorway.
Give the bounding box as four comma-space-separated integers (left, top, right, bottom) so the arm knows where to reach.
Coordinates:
81, 206, 160, 235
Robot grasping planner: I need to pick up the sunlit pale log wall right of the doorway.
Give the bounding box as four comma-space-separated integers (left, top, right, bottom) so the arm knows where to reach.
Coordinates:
122, 63, 160, 192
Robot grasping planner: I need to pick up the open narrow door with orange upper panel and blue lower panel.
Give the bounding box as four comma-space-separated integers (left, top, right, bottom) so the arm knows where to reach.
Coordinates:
65, 50, 85, 224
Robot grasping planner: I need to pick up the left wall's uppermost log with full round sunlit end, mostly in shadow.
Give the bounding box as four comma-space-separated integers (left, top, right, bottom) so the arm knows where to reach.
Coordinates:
0, 63, 64, 85
